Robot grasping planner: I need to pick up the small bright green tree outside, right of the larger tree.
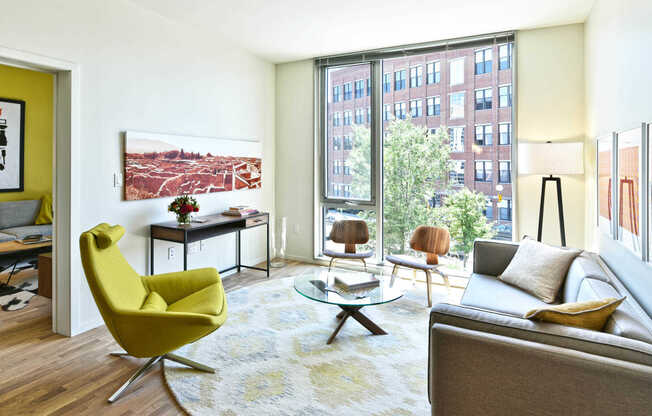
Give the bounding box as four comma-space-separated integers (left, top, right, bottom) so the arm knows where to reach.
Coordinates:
445, 188, 495, 267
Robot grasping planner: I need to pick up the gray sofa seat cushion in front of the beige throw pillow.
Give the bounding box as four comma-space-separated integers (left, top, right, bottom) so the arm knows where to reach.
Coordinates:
460, 273, 549, 318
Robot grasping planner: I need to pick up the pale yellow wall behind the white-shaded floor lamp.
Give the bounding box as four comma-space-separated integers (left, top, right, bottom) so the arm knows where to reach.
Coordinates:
516, 24, 587, 248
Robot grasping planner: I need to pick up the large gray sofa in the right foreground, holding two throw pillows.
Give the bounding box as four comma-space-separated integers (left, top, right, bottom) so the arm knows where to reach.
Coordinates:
428, 240, 652, 416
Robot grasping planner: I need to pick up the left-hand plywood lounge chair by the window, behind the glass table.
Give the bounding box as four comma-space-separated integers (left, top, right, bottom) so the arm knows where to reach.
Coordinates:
324, 220, 374, 270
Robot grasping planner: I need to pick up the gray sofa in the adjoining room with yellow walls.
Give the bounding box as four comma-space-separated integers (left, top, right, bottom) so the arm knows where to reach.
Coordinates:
0, 199, 52, 243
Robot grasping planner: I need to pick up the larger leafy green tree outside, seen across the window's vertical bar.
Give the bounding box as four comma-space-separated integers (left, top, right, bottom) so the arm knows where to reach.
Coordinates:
349, 118, 450, 254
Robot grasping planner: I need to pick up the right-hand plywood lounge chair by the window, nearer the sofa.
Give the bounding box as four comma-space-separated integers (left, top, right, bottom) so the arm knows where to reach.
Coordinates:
386, 225, 451, 307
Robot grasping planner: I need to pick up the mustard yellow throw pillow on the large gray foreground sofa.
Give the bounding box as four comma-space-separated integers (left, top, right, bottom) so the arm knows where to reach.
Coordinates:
523, 297, 625, 331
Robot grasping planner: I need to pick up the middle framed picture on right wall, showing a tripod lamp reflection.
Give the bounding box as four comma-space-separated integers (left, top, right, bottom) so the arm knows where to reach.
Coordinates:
616, 127, 643, 255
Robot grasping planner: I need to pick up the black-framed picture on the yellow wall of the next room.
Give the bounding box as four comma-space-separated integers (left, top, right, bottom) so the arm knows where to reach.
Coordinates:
0, 98, 25, 192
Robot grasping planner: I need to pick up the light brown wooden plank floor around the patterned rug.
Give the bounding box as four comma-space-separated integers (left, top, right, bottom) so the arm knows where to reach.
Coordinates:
0, 262, 461, 416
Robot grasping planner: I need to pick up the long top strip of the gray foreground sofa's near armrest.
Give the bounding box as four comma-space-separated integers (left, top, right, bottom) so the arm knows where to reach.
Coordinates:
430, 303, 652, 366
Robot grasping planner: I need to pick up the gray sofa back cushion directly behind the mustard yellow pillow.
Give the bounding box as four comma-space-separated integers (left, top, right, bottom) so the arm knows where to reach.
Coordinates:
578, 279, 652, 344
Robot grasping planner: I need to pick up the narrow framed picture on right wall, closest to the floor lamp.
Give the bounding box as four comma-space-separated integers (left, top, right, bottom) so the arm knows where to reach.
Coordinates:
596, 135, 613, 237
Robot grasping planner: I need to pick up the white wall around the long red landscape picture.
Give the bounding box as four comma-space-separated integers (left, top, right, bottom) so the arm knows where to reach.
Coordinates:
0, 0, 275, 332
